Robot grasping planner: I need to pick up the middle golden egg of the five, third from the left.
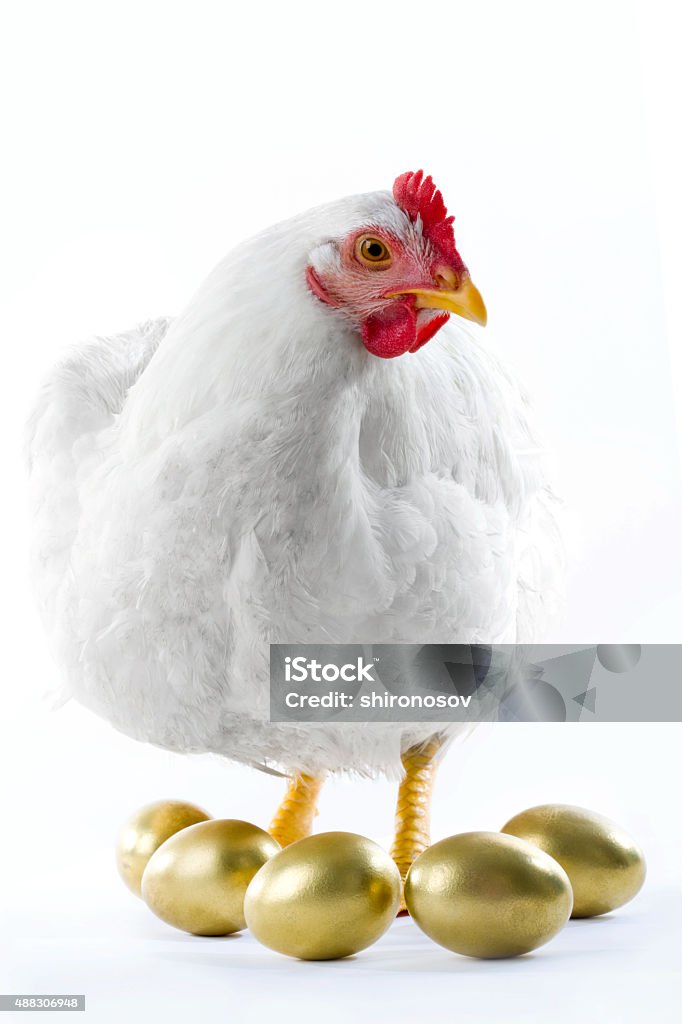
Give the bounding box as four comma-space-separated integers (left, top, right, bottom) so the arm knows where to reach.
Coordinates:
245, 833, 400, 959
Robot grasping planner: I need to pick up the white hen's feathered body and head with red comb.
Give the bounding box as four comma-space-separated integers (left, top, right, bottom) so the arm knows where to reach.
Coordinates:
29, 172, 559, 860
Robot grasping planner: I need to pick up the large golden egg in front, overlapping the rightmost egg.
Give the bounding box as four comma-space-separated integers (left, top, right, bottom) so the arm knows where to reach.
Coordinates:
404, 833, 572, 958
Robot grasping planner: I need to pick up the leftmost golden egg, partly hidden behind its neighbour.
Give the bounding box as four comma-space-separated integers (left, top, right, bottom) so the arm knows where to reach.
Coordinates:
116, 800, 211, 896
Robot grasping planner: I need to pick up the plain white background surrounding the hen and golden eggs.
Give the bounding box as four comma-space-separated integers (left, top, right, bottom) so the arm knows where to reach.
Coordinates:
0, 0, 682, 1022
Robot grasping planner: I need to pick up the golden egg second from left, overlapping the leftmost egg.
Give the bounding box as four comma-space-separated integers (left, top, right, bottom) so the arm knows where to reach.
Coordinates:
142, 818, 280, 935
